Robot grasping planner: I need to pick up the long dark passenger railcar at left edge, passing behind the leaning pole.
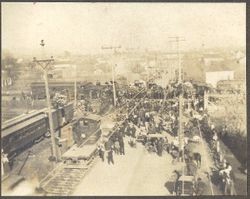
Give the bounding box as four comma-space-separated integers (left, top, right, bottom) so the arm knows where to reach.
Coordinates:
1, 103, 74, 159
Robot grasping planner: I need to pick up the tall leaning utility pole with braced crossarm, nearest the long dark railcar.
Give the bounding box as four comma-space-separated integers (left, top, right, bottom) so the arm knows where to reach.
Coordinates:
33, 40, 58, 161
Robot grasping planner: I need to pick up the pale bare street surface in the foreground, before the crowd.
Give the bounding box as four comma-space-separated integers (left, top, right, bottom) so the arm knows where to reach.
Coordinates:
73, 134, 221, 196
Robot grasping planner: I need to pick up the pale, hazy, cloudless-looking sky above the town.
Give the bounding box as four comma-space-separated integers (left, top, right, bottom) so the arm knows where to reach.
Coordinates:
2, 3, 246, 54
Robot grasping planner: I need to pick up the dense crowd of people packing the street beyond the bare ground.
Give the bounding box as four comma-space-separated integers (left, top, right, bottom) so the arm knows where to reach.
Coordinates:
93, 79, 243, 195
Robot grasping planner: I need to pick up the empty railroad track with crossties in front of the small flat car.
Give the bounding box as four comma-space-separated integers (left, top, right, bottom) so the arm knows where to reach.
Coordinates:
40, 155, 99, 196
